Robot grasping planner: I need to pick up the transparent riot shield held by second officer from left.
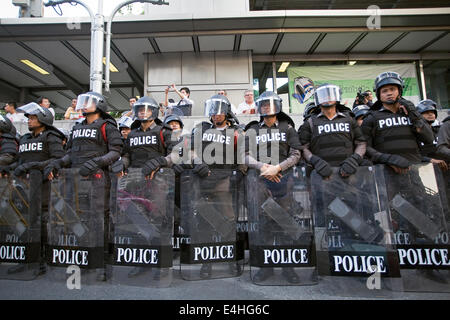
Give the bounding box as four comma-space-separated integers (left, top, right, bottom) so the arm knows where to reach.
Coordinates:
46, 168, 106, 284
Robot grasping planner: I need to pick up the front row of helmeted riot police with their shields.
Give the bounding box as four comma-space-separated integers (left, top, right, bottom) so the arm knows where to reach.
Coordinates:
0, 72, 448, 292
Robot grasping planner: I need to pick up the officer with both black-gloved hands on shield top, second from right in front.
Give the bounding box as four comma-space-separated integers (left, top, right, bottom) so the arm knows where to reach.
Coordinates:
298, 84, 366, 178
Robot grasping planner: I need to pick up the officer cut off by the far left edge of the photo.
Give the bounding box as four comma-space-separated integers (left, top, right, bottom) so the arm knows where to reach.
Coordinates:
0, 115, 18, 178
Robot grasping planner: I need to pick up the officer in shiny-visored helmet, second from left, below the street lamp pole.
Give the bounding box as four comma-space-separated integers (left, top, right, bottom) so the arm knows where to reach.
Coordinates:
44, 91, 123, 280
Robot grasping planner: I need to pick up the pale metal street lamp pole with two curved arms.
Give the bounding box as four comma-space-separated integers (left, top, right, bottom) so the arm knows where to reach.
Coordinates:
45, 0, 169, 94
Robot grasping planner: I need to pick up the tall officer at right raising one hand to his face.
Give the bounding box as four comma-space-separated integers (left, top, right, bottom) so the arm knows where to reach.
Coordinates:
361, 72, 433, 173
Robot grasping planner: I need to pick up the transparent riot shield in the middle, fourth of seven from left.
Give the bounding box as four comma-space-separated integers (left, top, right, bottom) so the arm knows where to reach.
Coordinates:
180, 169, 244, 280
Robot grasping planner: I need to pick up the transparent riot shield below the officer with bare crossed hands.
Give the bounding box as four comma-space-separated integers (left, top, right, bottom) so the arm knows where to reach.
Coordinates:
246, 167, 317, 285
